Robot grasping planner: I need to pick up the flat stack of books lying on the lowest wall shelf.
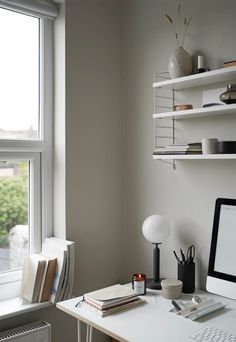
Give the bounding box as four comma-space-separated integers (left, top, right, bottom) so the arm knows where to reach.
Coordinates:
153, 143, 202, 155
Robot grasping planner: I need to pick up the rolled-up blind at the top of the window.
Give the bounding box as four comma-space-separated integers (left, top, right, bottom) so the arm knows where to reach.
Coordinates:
0, 0, 58, 19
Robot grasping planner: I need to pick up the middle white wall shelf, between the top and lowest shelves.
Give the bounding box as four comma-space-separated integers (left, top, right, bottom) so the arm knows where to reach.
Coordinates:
153, 103, 236, 119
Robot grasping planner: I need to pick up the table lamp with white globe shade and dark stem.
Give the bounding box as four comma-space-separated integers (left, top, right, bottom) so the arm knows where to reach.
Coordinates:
142, 215, 171, 290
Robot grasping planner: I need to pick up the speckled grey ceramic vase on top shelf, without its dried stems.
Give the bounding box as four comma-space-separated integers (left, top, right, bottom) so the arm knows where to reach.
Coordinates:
168, 46, 193, 78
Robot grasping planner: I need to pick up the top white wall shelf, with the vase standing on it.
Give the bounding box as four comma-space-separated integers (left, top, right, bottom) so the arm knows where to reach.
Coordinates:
153, 66, 236, 90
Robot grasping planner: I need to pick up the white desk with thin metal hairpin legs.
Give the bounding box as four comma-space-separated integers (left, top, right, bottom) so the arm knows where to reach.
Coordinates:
57, 290, 236, 342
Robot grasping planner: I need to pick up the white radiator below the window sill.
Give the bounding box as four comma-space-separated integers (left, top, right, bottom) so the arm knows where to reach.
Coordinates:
0, 321, 51, 342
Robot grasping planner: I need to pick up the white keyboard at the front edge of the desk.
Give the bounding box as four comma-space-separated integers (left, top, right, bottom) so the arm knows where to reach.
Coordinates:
188, 325, 236, 342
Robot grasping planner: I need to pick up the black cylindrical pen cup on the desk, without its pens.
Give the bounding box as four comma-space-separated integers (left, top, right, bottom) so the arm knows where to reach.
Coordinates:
178, 262, 195, 293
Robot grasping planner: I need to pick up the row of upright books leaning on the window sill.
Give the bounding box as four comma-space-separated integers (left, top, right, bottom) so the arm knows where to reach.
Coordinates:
21, 238, 74, 303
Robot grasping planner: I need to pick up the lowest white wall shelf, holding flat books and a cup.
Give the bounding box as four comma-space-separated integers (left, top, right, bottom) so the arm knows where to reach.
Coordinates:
153, 154, 236, 160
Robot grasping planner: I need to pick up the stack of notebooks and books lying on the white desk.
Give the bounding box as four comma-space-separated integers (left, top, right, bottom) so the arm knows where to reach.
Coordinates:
83, 284, 145, 317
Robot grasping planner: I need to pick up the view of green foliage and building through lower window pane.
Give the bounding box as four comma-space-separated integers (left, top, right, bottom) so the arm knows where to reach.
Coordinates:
0, 160, 29, 272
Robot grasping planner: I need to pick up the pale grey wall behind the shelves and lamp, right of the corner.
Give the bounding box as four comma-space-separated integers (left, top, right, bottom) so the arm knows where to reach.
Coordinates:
124, 0, 236, 288
